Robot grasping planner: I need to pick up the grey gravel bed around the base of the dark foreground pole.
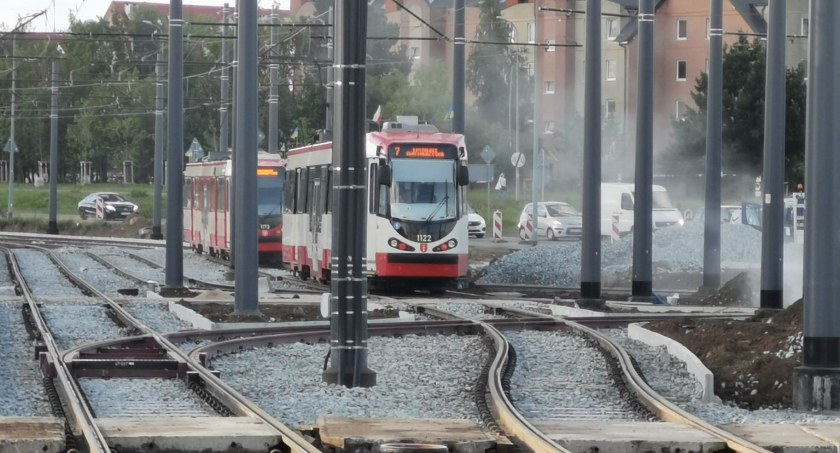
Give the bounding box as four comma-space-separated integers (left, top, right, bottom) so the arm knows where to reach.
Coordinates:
213, 335, 488, 426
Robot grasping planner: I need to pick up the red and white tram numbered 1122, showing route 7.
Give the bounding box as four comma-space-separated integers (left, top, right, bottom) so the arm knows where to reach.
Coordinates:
283, 120, 469, 289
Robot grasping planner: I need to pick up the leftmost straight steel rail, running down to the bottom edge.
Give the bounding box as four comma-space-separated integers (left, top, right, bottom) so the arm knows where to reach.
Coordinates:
3, 247, 111, 453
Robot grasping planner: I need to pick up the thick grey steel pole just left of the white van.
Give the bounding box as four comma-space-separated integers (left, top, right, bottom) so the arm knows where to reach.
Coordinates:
580, 0, 602, 300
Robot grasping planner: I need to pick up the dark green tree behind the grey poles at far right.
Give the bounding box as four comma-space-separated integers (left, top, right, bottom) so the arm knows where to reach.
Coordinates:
661, 36, 806, 182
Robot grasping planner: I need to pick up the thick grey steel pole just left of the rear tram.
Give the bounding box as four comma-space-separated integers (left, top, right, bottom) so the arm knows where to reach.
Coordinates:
166, 0, 184, 290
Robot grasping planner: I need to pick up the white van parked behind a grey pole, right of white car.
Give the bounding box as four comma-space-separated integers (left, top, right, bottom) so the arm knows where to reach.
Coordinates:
601, 182, 684, 236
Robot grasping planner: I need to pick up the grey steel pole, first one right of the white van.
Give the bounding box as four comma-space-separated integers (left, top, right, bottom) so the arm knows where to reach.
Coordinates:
701, 0, 723, 292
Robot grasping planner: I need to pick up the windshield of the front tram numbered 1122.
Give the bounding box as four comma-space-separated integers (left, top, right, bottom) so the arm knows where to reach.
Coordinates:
391, 159, 458, 221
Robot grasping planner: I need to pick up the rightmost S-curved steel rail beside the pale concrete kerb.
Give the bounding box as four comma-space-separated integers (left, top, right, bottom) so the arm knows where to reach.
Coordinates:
563, 320, 770, 453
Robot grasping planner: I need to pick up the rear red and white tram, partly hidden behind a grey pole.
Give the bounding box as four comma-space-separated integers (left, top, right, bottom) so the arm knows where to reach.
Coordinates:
184, 152, 286, 262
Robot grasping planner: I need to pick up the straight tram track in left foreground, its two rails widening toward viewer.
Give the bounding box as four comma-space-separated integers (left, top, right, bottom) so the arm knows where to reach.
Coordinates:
3, 244, 324, 452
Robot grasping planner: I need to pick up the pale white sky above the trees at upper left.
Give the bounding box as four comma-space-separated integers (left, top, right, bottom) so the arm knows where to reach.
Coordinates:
0, 0, 288, 32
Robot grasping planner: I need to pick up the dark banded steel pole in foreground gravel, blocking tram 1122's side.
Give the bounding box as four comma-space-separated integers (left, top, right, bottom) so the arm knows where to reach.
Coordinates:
322, 0, 376, 387
